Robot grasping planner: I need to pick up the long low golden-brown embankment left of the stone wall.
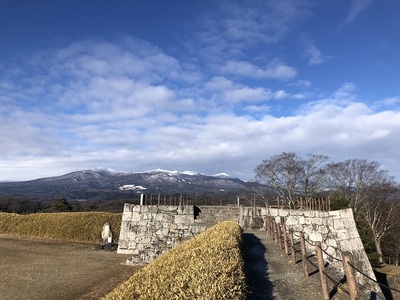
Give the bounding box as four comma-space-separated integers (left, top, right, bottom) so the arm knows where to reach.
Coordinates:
0, 212, 122, 243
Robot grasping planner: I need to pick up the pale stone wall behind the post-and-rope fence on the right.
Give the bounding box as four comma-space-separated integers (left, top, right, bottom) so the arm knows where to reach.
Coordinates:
239, 207, 379, 291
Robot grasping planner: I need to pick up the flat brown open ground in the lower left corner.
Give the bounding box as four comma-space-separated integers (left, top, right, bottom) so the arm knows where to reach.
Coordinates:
0, 235, 136, 300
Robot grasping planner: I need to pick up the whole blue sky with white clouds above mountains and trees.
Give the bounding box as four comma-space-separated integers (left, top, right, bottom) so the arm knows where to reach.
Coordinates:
0, 0, 400, 180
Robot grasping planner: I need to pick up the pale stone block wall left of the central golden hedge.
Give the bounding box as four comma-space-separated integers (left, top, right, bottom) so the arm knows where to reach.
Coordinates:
117, 204, 207, 264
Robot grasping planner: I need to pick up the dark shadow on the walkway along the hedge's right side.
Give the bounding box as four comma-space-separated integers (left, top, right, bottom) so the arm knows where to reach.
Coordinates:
243, 233, 274, 300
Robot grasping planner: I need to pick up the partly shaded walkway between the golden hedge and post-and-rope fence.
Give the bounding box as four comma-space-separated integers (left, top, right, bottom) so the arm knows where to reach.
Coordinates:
244, 230, 326, 300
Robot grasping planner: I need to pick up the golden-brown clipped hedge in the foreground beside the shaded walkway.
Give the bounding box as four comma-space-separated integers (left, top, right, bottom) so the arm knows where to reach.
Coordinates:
104, 221, 246, 300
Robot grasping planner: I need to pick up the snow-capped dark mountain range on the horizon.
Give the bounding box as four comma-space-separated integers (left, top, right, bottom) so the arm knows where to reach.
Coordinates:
0, 169, 259, 201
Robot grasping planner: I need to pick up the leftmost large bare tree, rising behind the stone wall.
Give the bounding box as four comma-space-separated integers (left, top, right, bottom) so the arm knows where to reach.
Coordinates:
255, 152, 328, 208
